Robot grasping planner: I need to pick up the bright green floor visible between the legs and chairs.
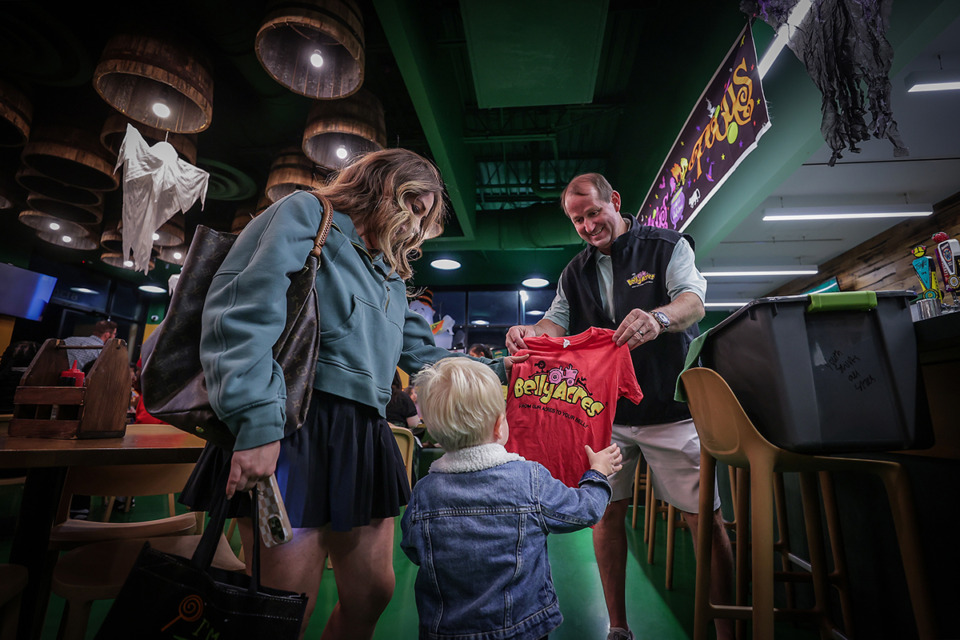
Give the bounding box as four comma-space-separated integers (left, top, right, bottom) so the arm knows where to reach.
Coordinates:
0, 487, 817, 640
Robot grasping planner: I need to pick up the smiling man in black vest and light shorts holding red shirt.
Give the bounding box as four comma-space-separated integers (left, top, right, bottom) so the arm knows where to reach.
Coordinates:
506, 173, 733, 640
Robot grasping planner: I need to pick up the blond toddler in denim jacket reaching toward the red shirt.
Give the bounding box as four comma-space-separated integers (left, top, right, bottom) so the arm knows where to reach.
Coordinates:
400, 358, 622, 640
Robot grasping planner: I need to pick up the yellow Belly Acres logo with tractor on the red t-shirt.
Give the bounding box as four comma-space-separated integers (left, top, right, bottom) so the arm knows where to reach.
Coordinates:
513, 362, 605, 427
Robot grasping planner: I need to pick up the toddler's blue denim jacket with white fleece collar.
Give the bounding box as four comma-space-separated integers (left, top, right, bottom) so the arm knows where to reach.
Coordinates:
400, 444, 611, 640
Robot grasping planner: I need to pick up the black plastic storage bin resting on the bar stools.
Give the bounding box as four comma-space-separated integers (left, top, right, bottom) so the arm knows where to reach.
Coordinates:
701, 291, 932, 453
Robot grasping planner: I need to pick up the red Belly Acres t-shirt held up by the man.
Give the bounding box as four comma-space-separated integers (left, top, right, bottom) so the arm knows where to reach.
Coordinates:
506, 327, 643, 487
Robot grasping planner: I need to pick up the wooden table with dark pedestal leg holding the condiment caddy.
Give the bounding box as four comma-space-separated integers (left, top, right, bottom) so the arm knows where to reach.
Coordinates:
0, 424, 204, 640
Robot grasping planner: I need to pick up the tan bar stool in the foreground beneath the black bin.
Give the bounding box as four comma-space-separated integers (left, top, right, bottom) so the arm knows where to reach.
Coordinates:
681, 368, 937, 640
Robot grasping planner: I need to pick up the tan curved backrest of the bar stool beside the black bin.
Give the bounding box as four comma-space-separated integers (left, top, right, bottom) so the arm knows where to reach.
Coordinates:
680, 367, 781, 467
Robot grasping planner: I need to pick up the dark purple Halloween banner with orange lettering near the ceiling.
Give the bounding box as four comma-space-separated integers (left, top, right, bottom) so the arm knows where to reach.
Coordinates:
637, 24, 770, 231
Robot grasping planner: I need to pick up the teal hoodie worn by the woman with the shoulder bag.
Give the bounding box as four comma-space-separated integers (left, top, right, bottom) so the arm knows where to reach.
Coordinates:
200, 191, 506, 451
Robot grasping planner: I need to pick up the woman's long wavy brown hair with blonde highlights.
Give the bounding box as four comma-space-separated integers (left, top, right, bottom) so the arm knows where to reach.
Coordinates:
317, 149, 446, 280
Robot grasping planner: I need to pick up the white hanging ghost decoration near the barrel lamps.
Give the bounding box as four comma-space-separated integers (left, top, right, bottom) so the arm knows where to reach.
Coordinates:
114, 123, 210, 273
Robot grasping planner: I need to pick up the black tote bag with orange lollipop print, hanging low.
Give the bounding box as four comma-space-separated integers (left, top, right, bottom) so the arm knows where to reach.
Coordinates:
95, 482, 306, 640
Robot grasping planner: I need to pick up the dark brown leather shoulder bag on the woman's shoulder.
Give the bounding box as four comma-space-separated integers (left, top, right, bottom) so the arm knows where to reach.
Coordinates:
140, 192, 333, 448
